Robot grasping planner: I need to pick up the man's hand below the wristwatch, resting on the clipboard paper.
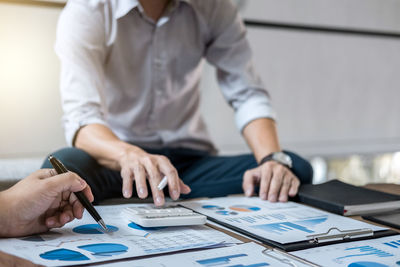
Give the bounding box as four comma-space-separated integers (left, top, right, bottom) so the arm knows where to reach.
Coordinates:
243, 161, 300, 202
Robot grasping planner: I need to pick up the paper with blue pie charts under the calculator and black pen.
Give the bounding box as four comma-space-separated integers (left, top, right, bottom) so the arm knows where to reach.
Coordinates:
0, 204, 238, 266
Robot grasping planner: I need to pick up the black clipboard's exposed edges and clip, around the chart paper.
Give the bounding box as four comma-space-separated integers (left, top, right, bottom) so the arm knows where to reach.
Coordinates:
191, 211, 398, 252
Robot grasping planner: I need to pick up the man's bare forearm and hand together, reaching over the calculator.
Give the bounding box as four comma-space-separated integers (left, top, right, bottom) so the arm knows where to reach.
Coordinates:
75, 124, 190, 206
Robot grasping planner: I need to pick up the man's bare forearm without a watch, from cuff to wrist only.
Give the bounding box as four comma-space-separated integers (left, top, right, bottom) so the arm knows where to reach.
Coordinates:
75, 124, 139, 170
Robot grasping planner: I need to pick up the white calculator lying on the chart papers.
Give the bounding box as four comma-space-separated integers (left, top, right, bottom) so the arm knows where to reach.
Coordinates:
122, 206, 207, 227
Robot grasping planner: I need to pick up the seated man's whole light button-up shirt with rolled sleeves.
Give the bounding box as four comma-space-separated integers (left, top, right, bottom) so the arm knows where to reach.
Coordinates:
56, 0, 275, 151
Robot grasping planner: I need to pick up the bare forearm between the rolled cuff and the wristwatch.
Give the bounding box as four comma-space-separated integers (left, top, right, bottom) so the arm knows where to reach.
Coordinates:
243, 118, 281, 162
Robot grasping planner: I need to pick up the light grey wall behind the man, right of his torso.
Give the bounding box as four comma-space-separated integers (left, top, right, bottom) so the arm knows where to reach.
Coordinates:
203, 0, 400, 156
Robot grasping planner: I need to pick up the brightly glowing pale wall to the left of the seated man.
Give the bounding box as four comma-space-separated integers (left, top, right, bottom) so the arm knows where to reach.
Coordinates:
0, 2, 64, 158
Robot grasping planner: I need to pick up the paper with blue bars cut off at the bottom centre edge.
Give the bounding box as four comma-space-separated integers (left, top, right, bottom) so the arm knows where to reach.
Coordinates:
99, 243, 309, 267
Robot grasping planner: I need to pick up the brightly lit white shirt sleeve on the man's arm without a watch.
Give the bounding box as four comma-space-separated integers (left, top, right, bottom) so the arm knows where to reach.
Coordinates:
55, 0, 107, 146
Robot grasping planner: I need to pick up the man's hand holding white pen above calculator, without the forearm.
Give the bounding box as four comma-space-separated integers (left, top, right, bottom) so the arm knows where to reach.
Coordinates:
119, 146, 190, 206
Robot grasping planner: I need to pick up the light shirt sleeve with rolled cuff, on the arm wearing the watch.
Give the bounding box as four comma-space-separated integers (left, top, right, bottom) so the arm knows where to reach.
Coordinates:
206, 1, 276, 131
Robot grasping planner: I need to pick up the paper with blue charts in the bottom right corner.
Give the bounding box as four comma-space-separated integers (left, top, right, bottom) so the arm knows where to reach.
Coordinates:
291, 235, 400, 267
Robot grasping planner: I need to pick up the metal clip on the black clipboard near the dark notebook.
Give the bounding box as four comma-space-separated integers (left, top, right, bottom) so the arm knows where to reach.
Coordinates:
307, 227, 374, 244
